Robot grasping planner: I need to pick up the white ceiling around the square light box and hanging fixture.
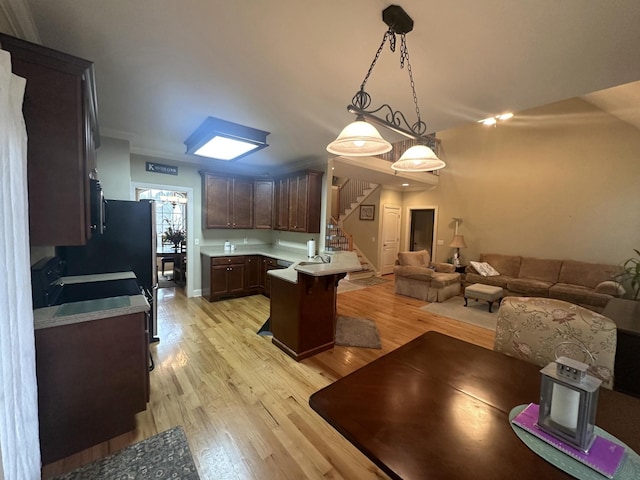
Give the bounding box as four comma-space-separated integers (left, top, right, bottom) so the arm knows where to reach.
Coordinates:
0, 0, 640, 185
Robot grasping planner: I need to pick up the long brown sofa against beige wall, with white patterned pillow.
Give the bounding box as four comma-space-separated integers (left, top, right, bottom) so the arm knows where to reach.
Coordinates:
465, 253, 625, 313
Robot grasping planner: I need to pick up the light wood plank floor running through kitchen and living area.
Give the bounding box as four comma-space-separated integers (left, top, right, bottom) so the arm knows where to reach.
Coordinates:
42, 276, 493, 480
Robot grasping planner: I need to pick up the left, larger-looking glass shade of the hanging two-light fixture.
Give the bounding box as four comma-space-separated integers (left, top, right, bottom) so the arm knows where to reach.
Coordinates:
327, 120, 393, 157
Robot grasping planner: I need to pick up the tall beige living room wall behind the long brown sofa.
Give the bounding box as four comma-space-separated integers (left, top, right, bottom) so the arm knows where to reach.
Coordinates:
402, 99, 640, 264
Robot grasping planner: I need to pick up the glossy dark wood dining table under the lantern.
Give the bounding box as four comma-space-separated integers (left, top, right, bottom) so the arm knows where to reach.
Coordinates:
309, 332, 640, 480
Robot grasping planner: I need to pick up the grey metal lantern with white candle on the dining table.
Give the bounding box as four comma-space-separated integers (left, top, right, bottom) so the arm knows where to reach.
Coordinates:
538, 357, 602, 452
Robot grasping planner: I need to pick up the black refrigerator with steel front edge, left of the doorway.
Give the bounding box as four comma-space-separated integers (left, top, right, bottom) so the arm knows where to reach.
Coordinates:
57, 200, 159, 342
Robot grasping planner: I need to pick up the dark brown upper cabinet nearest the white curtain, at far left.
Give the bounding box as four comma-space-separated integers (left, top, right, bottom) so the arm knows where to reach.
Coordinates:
0, 34, 100, 246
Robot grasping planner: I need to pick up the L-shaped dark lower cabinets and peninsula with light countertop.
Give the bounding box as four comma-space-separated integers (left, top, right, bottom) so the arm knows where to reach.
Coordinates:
200, 245, 362, 360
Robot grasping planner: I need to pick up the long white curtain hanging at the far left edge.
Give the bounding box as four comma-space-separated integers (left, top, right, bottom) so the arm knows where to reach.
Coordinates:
0, 50, 40, 480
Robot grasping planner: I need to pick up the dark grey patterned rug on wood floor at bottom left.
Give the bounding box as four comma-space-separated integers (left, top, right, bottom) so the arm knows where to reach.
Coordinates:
53, 426, 200, 480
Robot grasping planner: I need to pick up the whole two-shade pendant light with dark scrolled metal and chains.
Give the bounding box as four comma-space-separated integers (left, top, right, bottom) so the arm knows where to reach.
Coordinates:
327, 5, 445, 172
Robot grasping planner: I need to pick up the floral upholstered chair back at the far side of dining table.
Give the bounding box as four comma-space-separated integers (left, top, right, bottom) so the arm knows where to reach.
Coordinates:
493, 297, 617, 389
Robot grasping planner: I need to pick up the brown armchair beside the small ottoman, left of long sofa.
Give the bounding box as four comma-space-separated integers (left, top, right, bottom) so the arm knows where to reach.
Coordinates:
393, 250, 462, 302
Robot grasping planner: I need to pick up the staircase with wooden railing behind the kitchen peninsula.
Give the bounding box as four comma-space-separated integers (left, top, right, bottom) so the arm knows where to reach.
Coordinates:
325, 179, 378, 280
